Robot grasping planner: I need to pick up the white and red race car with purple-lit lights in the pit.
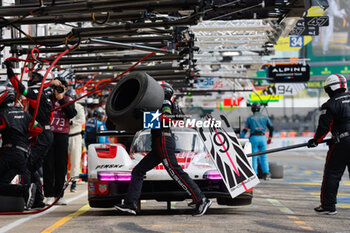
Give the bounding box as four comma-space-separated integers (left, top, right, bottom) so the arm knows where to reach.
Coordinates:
88, 128, 253, 208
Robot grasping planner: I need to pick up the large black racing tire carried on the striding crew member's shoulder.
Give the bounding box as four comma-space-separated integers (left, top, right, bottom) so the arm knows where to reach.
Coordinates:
106, 72, 164, 132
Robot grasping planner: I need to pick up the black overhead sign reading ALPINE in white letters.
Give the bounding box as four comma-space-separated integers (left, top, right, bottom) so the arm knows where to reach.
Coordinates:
267, 64, 310, 83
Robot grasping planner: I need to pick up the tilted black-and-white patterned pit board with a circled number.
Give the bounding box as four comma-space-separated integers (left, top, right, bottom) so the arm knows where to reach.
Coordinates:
197, 114, 259, 198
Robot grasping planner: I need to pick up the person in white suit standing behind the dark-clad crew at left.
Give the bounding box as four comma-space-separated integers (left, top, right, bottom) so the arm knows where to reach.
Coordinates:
66, 89, 85, 192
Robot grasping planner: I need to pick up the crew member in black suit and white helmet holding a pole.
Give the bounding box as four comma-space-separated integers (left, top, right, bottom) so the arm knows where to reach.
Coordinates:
308, 74, 350, 215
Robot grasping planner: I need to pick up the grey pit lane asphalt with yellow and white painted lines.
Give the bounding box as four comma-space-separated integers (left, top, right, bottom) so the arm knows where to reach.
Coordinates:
0, 151, 350, 233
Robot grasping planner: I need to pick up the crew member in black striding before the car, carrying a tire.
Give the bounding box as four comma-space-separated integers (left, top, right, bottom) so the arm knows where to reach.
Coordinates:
115, 83, 212, 216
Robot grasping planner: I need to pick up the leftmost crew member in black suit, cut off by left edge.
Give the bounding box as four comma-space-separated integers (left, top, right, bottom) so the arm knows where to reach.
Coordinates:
0, 89, 42, 209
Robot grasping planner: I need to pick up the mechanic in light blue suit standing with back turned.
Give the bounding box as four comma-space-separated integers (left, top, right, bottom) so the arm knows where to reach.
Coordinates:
241, 103, 273, 180
